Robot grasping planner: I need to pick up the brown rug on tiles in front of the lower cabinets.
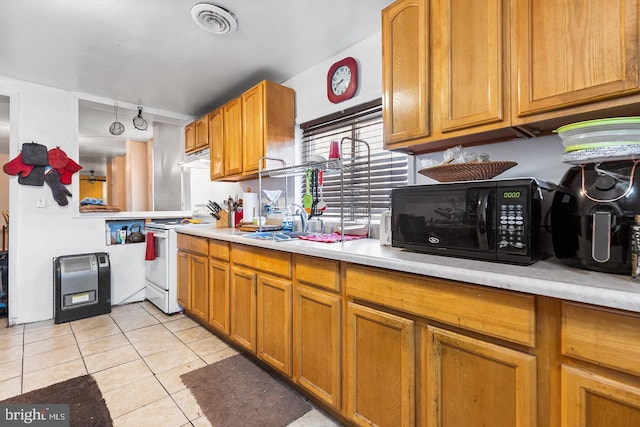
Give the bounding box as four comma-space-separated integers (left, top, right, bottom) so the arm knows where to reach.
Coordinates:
180, 354, 311, 427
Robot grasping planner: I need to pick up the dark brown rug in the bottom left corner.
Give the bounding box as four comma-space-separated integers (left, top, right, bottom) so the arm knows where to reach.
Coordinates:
0, 375, 113, 427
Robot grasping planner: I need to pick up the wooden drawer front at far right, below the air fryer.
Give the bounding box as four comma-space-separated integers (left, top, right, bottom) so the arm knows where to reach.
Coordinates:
562, 302, 640, 375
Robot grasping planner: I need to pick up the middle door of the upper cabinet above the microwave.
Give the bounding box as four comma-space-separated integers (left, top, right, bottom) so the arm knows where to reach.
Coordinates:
432, 0, 510, 133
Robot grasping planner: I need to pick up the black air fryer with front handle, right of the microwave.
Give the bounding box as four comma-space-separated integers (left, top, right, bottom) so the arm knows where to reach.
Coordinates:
551, 160, 640, 274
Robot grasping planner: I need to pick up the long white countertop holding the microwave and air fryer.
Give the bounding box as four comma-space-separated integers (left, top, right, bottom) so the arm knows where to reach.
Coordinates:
177, 225, 640, 312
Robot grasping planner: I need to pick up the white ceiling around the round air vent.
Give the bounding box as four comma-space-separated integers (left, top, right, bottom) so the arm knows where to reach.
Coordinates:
0, 0, 391, 116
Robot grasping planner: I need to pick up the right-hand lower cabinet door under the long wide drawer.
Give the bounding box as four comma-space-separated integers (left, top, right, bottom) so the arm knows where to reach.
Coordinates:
422, 326, 537, 427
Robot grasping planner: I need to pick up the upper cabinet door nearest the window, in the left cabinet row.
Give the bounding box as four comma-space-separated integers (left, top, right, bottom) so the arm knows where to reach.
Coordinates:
241, 83, 266, 173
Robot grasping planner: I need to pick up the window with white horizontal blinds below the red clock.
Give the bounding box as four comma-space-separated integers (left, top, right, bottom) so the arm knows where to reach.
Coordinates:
301, 99, 408, 221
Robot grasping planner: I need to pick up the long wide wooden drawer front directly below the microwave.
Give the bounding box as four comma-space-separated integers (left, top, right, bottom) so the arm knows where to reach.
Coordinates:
346, 264, 535, 347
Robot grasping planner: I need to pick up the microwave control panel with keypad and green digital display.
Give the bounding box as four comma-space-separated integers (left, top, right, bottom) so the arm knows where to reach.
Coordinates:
496, 187, 530, 253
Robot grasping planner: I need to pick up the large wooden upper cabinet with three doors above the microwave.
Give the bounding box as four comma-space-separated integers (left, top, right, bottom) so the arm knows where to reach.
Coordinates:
382, 0, 640, 153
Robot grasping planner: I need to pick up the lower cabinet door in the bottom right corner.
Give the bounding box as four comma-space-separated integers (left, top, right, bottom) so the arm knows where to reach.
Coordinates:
561, 365, 640, 427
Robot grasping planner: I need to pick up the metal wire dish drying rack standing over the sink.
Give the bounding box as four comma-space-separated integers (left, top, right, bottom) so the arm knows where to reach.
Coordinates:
258, 137, 371, 241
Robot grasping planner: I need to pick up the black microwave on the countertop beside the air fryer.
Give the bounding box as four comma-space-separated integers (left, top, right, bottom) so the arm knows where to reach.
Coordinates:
391, 178, 556, 265
